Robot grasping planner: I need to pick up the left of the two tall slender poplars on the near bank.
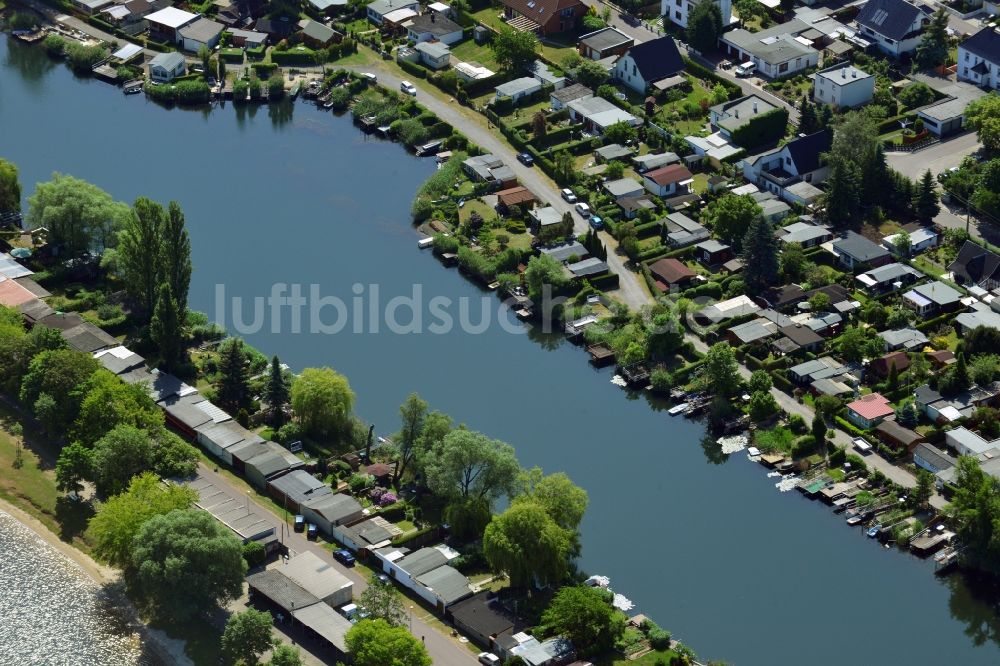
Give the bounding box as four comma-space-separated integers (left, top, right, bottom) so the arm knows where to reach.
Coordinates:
118, 197, 166, 317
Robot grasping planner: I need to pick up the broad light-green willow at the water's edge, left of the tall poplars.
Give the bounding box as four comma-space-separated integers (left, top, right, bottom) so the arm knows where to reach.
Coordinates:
25, 173, 130, 257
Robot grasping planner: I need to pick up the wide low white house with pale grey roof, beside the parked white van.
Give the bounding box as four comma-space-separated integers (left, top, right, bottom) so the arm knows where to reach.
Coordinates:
719, 18, 819, 79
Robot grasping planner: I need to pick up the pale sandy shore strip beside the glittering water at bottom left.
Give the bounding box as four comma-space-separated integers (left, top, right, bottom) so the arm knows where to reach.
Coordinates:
0, 498, 194, 666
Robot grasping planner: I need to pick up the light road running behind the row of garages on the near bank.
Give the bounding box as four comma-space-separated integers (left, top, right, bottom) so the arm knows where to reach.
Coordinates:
198, 463, 476, 666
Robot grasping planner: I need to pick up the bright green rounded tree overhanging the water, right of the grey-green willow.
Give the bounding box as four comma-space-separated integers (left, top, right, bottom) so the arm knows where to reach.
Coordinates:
483, 502, 573, 587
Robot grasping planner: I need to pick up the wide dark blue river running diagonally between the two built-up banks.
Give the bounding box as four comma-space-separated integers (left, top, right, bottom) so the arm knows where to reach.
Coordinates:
0, 33, 1000, 666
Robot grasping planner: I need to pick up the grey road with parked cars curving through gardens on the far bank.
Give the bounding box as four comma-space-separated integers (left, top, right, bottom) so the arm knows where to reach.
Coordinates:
346, 63, 652, 310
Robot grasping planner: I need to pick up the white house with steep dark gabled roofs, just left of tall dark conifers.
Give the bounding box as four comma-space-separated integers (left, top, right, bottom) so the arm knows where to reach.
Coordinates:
739, 130, 833, 201
